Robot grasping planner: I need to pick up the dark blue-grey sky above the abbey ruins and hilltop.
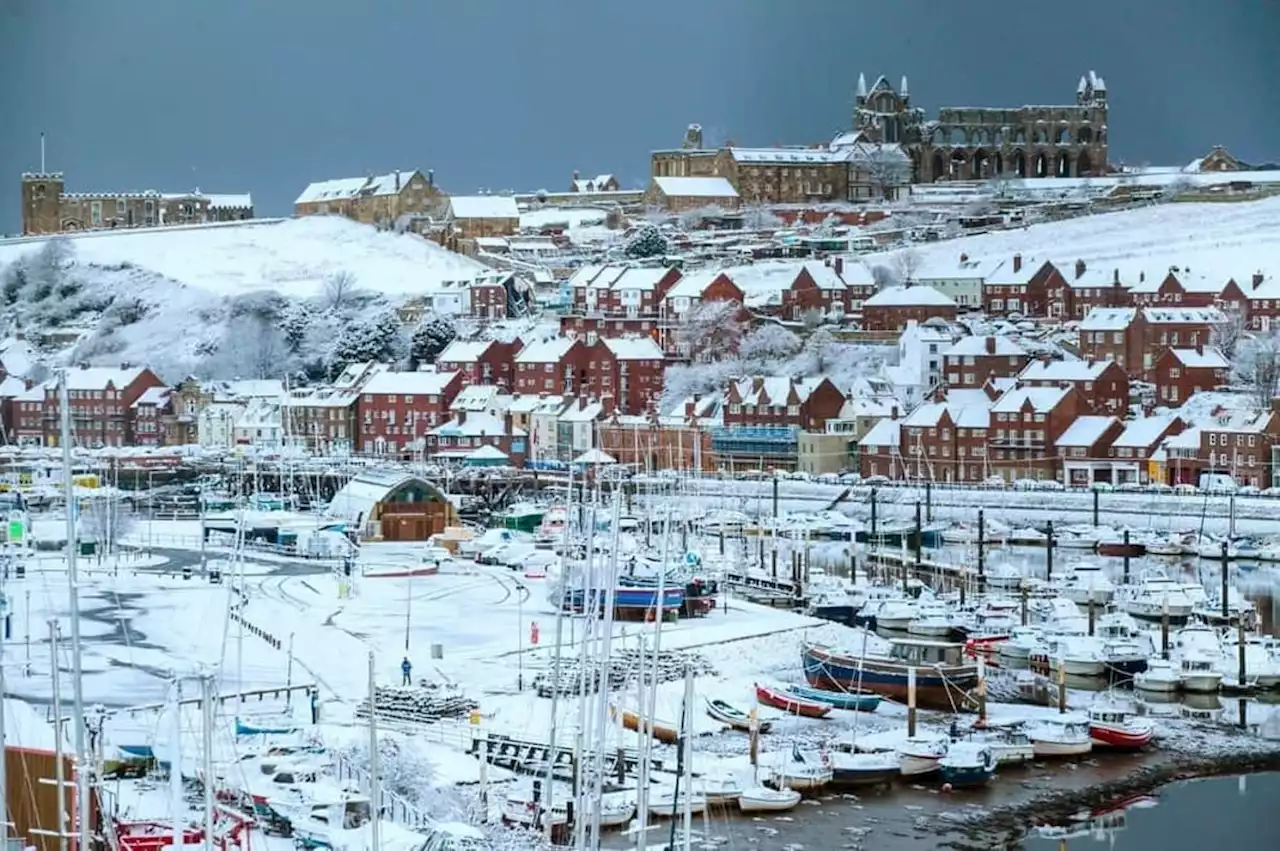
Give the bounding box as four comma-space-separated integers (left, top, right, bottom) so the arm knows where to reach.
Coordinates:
0, 0, 1280, 233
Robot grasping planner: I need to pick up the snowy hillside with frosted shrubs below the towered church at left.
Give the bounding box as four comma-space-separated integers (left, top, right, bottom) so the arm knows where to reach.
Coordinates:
0, 216, 492, 374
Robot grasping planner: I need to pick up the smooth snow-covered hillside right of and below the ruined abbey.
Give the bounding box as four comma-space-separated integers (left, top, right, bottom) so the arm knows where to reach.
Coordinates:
885, 197, 1280, 280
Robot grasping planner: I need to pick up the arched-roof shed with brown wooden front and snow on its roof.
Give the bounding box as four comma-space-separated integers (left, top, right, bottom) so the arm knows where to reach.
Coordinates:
328, 470, 458, 541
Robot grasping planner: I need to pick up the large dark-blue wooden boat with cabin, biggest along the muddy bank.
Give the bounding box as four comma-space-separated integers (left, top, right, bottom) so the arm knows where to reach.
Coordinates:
800, 639, 978, 712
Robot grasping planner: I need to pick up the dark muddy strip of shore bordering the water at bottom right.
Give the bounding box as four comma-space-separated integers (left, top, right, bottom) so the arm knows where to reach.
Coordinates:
934, 736, 1280, 851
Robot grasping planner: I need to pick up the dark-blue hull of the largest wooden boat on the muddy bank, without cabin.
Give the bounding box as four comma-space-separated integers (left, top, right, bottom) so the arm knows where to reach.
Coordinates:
801, 646, 978, 710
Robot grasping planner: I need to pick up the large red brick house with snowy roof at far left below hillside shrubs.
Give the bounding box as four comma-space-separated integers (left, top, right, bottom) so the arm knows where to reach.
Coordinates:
41, 365, 164, 447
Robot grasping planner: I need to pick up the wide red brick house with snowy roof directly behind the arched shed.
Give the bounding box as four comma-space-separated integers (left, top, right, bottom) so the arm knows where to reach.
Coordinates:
356, 370, 463, 456
